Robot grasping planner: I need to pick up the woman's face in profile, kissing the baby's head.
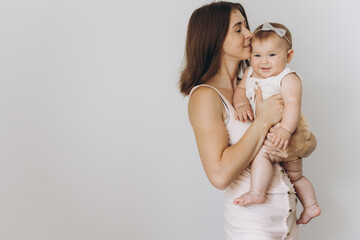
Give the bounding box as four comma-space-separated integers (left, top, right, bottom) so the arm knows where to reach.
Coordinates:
222, 9, 252, 61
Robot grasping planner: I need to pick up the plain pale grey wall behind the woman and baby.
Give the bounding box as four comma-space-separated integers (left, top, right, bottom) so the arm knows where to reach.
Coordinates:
0, 0, 360, 240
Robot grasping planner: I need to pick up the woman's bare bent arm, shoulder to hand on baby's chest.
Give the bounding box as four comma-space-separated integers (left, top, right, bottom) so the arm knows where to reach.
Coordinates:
189, 88, 283, 189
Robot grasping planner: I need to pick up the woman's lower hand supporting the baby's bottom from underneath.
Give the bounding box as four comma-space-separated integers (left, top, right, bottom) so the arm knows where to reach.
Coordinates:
264, 126, 316, 162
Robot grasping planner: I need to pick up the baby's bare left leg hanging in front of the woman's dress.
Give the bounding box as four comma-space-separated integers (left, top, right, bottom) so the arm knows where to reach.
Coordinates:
234, 146, 273, 206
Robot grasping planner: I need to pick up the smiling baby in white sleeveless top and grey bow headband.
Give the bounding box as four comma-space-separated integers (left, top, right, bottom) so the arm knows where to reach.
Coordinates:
233, 23, 321, 224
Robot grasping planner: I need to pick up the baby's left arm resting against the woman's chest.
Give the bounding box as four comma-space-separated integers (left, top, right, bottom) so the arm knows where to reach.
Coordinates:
233, 69, 254, 122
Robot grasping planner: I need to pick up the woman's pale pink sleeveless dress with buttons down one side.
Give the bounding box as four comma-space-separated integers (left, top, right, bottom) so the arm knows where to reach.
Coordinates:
190, 84, 298, 240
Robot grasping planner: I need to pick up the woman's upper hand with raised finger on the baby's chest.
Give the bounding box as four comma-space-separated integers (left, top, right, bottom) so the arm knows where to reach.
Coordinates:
255, 87, 284, 126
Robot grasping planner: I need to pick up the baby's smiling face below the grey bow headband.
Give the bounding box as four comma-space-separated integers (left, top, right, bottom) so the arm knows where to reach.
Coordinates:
251, 36, 288, 78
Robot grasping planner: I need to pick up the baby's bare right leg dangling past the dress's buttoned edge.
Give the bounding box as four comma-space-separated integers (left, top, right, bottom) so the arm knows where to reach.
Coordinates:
282, 160, 321, 224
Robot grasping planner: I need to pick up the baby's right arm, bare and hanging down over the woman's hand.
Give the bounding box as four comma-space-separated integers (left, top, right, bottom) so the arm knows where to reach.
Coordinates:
272, 74, 302, 149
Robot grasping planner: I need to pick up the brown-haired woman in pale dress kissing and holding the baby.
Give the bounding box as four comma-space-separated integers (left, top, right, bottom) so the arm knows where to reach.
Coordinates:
180, 2, 316, 240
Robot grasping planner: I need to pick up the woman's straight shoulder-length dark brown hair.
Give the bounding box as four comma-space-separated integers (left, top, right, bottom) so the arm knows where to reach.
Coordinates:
179, 2, 249, 96
